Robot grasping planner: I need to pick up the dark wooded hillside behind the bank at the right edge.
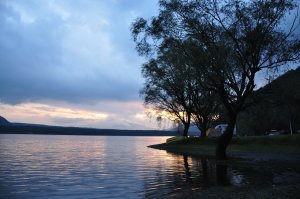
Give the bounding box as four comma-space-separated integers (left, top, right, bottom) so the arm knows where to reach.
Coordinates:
237, 67, 300, 135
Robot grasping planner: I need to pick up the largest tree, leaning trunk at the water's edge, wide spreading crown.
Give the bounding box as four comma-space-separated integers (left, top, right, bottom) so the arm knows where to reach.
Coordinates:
132, 0, 300, 159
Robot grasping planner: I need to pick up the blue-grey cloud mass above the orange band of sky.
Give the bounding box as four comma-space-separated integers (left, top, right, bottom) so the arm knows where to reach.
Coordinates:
0, 1, 156, 104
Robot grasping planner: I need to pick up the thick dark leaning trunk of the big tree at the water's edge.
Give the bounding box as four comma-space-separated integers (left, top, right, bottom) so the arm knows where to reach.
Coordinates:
216, 116, 236, 160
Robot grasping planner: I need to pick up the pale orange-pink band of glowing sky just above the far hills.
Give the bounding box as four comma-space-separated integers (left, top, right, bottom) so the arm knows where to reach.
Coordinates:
0, 101, 166, 130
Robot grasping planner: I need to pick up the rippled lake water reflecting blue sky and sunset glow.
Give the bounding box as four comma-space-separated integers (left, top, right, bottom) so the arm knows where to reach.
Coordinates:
0, 134, 298, 198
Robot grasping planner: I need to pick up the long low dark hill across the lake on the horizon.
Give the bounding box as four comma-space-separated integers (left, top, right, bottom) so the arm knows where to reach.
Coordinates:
0, 116, 176, 136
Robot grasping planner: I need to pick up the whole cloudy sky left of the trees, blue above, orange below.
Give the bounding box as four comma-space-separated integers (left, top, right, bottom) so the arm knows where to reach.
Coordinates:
0, 0, 166, 129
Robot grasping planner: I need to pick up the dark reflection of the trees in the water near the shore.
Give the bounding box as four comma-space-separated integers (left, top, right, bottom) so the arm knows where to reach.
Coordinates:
144, 153, 247, 198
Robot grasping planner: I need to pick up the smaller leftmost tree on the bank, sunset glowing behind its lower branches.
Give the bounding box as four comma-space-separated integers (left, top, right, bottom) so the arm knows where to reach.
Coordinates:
141, 39, 193, 136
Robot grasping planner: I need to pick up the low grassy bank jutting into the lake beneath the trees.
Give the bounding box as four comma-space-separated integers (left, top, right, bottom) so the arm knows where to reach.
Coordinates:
149, 135, 300, 157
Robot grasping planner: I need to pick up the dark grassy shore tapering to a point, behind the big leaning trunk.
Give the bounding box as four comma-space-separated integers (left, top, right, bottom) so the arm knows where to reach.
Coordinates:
148, 135, 300, 162
